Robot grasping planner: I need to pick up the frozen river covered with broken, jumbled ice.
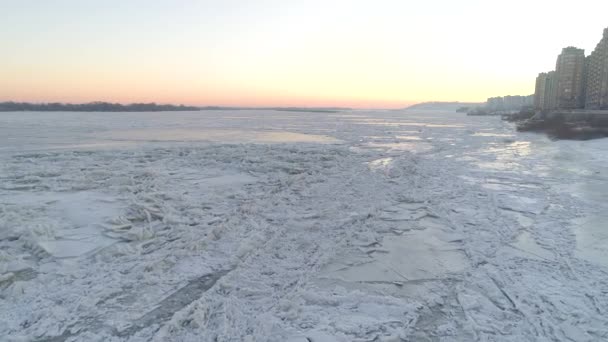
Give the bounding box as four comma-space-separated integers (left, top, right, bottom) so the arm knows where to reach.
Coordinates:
0, 110, 608, 342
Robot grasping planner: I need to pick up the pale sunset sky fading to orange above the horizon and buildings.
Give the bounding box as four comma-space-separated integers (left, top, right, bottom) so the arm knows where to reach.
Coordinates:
0, 0, 608, 108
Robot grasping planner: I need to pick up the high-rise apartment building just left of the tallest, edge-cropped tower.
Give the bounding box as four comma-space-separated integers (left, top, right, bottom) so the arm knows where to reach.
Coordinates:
555, 46, 585, 109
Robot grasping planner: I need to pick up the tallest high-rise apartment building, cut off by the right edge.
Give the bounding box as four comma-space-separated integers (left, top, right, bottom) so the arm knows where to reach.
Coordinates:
585, 28, 608, 109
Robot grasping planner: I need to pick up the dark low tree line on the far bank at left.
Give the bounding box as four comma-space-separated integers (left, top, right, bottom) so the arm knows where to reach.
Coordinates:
0, 102, 200, 112
